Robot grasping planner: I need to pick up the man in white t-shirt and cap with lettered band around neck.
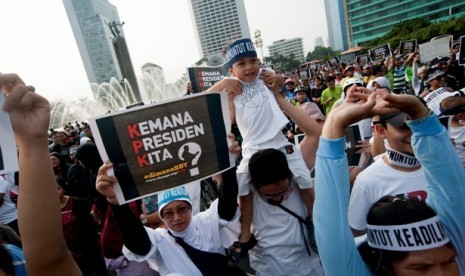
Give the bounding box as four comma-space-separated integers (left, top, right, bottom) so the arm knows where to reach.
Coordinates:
349, 112, 427, 237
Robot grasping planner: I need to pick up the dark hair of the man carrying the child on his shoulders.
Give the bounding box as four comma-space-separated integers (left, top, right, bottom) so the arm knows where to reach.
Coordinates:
249, 149, 292, 189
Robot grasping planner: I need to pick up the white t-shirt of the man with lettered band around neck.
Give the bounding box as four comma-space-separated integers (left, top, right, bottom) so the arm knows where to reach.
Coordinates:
349, 154, 426, 231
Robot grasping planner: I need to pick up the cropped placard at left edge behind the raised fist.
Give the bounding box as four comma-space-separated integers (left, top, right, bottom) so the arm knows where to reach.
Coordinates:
0, 94, 18, 174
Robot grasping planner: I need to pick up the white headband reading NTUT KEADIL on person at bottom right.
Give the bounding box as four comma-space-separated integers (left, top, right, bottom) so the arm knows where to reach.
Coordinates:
367, 216, 449, 251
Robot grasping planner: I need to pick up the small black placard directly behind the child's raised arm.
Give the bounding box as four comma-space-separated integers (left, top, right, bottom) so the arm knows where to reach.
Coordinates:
187, 63, 229, 92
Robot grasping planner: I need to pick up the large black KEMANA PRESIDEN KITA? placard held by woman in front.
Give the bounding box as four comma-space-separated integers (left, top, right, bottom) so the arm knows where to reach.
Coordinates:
89, 93, 234, 203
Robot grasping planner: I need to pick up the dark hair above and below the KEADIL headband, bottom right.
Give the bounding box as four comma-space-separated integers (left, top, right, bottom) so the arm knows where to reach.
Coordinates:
358, 196, 436, 276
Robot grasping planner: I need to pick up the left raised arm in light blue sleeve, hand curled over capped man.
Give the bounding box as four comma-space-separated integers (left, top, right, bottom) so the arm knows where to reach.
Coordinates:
313, 86, 396, 275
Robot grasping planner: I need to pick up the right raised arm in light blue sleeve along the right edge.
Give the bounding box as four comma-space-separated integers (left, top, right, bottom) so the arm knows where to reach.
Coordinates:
385, 92, 465, 275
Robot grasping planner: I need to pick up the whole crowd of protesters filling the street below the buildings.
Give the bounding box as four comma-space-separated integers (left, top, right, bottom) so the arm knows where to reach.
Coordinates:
0, 35, 465, 276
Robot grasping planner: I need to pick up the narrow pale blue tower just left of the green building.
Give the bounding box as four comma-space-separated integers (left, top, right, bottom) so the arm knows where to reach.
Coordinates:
325, 0, 346, 51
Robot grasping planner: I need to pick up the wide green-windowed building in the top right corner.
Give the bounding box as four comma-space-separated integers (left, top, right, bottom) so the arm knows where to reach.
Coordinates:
345, 0, 465, 46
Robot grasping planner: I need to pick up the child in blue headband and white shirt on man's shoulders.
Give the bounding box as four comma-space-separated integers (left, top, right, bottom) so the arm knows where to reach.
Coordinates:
208, 38, 313, 260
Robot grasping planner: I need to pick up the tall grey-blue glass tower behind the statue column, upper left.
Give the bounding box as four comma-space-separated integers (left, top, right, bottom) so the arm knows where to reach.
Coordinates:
63, 0, 124, 84
